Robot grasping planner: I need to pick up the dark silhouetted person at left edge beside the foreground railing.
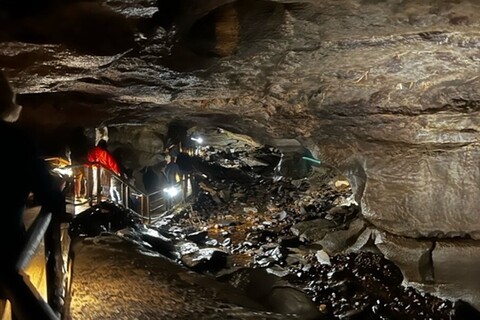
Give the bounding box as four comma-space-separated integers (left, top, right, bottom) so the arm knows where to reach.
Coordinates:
0, 70, 67, 319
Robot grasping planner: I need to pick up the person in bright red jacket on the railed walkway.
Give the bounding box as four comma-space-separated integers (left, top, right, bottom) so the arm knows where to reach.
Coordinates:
88, 139, 121, 202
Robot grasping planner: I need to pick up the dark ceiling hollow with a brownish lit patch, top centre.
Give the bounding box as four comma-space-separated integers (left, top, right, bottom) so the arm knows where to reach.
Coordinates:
146, 0, 286, 71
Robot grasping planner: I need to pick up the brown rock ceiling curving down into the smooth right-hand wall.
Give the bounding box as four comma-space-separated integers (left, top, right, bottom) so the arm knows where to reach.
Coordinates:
0, 0, 480, 238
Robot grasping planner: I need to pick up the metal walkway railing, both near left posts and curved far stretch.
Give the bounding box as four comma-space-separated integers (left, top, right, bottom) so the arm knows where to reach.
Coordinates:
4, 158, 195, 320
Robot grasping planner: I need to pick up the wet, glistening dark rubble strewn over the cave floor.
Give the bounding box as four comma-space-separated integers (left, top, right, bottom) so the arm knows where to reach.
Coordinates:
154, 148, 462, 319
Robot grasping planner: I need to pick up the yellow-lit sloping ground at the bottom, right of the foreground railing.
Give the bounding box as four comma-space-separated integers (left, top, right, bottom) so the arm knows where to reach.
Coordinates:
71, 236, 297, 320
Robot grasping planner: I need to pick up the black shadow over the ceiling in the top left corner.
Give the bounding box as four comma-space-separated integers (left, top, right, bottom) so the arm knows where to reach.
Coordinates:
0, 1, 135, 55
